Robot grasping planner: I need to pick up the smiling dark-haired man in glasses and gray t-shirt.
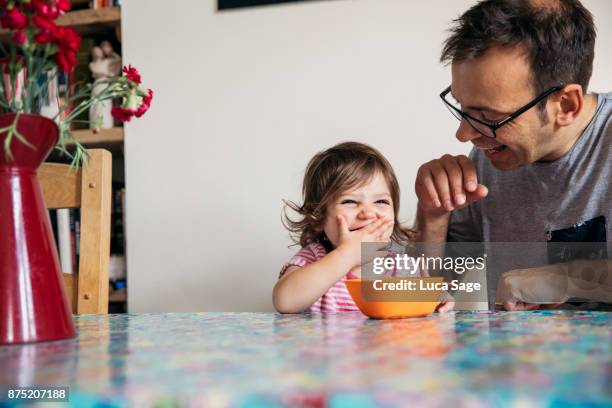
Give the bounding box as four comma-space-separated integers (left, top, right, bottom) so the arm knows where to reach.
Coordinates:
415, 0, 612, 310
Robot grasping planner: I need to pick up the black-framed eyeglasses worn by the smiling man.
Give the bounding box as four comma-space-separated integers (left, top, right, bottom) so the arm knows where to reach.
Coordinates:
440, 85, 563, 138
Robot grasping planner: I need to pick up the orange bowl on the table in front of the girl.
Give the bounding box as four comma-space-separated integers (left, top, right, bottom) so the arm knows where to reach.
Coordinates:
344, 277, 442, 319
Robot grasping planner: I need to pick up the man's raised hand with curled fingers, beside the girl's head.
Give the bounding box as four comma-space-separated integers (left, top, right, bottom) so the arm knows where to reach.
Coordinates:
415, 154, 488, 218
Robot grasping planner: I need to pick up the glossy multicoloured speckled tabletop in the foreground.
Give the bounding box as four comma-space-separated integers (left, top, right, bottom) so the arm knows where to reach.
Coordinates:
0, 311, 612, 408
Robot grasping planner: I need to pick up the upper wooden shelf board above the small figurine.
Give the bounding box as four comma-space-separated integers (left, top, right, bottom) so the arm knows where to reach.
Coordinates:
0, 7, 121, 37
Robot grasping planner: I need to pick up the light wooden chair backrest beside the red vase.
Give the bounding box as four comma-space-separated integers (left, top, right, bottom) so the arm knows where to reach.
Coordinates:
38, 149, 112, 314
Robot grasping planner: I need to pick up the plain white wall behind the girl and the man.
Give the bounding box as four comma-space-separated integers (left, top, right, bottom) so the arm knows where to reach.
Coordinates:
122, 0, 612, 312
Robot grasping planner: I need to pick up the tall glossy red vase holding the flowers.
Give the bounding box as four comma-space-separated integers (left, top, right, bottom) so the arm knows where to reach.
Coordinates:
0, 114, 75, 344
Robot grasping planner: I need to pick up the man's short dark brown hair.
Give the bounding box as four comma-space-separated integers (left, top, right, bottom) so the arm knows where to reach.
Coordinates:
440, 0, 595, 94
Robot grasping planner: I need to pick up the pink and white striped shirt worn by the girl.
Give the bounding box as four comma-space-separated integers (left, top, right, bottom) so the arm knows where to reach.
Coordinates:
279, 243, 359, 313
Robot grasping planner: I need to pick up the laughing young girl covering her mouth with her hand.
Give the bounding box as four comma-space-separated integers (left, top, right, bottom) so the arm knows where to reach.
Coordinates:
273, 142, 410, 313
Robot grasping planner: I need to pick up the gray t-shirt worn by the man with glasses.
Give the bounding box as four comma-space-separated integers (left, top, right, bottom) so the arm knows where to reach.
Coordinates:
447, 93, 612, 302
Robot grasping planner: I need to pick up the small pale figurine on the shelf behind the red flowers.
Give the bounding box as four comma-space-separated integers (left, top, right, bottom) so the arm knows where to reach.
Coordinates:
89, 41, 121, 129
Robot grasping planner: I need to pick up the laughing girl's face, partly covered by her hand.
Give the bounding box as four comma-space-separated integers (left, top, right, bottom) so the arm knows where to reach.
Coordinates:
323, 172, 395, 248
